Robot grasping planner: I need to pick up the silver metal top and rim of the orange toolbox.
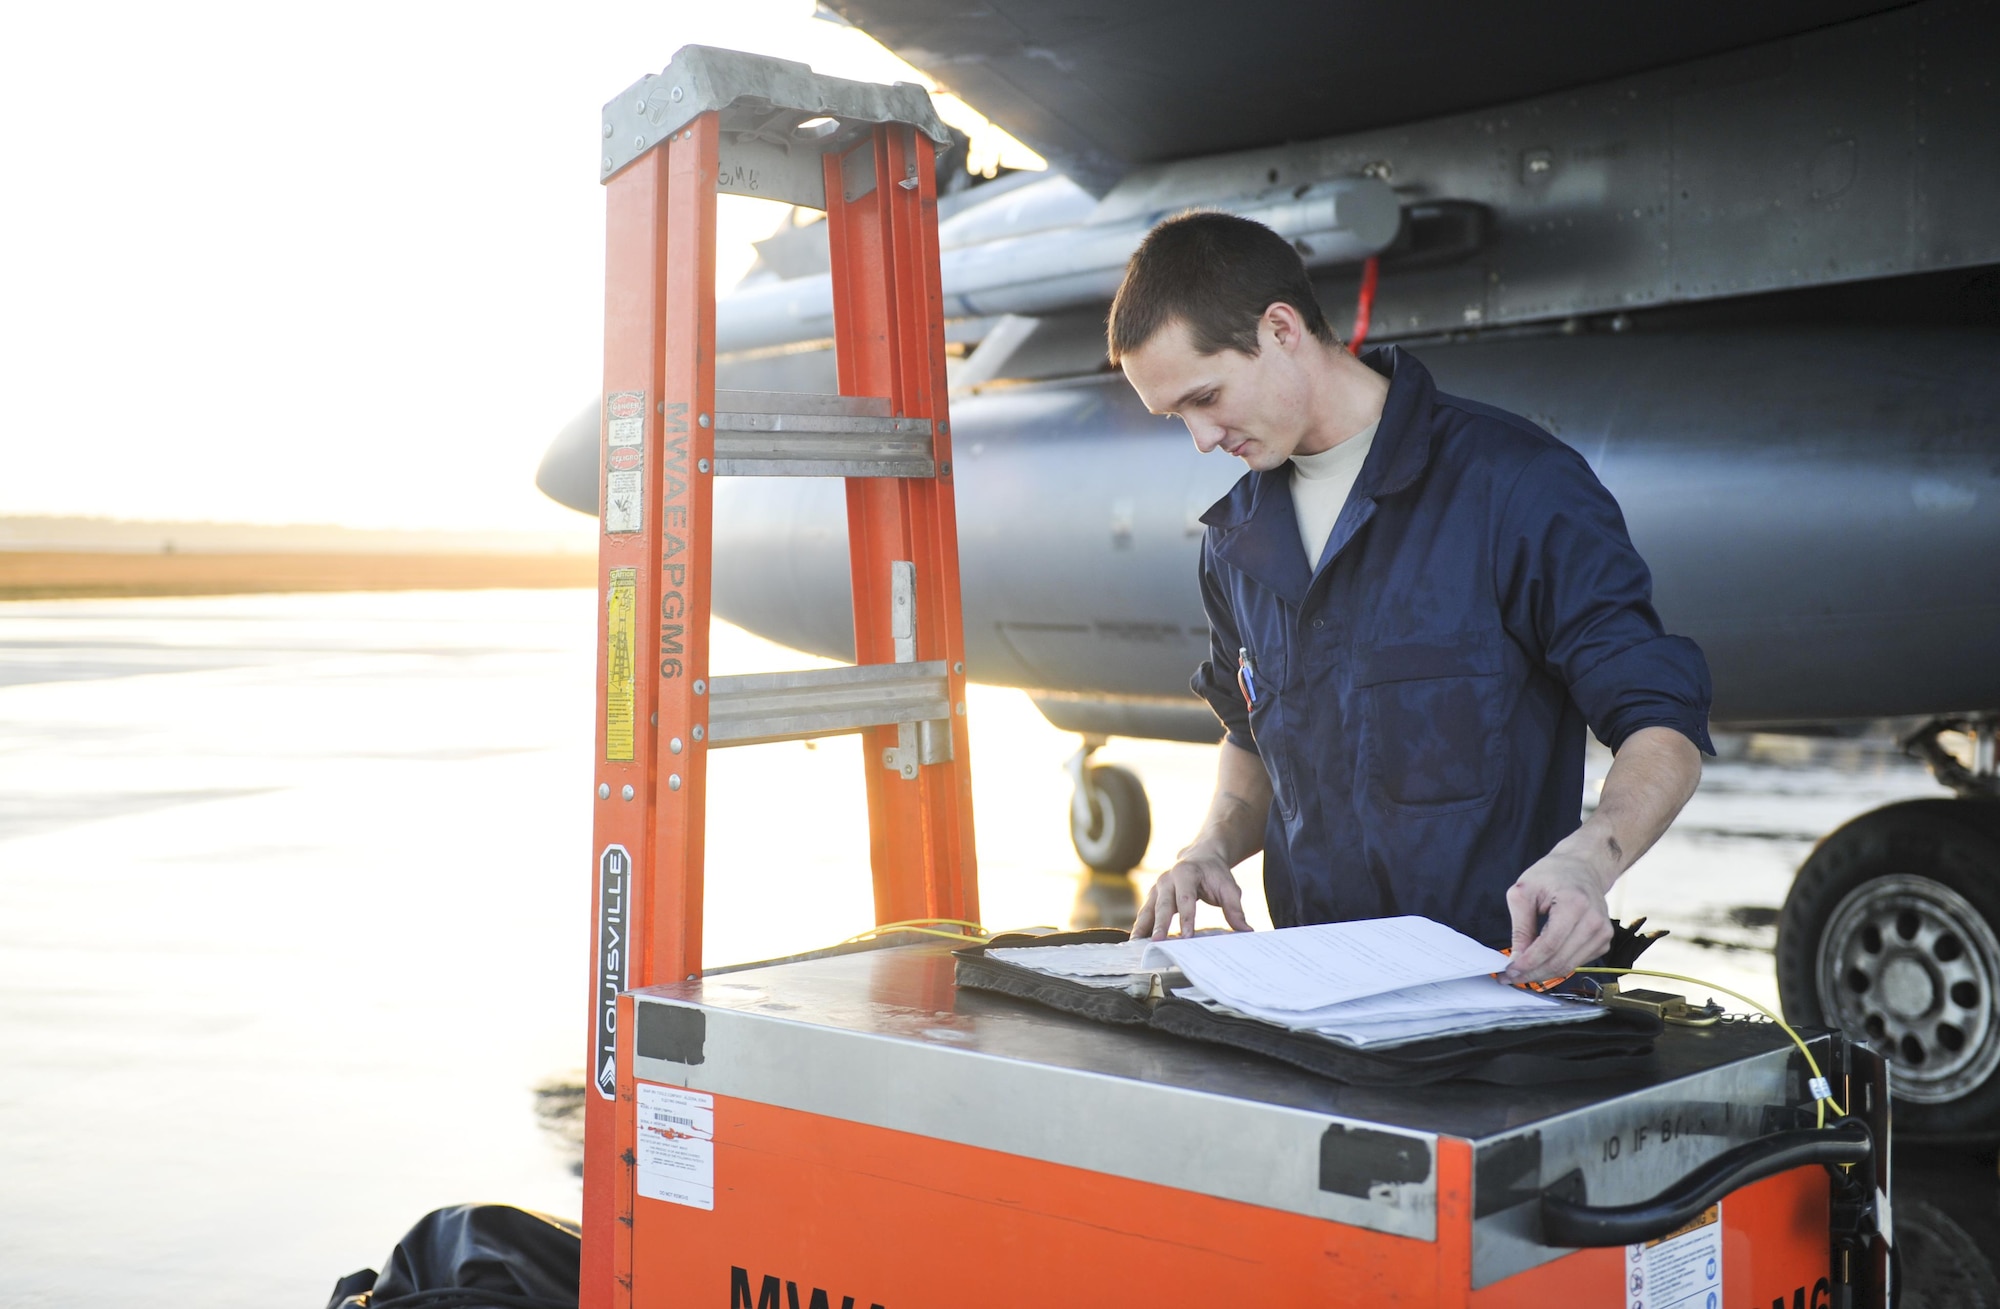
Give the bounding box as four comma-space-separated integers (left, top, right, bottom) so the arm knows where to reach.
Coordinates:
628, 943, 1802, 1264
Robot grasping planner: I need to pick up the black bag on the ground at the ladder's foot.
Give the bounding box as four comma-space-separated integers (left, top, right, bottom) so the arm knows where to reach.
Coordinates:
326, 1205, 582, 1309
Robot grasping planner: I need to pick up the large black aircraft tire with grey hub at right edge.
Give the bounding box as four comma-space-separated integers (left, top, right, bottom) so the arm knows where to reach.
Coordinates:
1778, 801, 2000, 1141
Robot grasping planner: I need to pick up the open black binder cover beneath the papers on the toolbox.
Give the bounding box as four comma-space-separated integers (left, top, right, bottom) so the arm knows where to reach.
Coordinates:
952, 931, 1664, 1087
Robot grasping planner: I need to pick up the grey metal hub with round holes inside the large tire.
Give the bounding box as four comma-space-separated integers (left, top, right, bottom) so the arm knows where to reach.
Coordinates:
1818, 875, 2000, 1103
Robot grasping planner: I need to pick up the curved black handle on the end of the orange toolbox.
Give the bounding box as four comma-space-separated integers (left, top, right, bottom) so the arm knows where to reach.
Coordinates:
1542, 1119, 1874, 1249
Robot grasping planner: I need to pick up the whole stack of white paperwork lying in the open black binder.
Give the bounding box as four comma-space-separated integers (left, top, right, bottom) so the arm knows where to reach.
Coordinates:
990, 917, 1602, 1047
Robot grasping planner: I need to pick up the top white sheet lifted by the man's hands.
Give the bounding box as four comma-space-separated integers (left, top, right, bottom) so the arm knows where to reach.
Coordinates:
1142, 917, 1506, 1013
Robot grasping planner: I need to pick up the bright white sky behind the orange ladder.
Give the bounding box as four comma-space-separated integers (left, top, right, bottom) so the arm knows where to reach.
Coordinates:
0, 0, 1032, 530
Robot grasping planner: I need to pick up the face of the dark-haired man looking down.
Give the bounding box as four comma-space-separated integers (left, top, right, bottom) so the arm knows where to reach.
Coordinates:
1120, 314, 1310, 470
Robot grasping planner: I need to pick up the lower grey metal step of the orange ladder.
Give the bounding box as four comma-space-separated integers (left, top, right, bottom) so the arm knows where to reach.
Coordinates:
708, 661, 952, 747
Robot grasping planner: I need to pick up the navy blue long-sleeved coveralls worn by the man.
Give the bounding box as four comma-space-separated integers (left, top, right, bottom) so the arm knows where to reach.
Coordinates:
1192, 346, 1714, 945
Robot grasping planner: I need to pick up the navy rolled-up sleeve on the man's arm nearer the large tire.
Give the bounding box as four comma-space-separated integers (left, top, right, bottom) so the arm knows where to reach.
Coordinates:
1496, 446, 1716, 755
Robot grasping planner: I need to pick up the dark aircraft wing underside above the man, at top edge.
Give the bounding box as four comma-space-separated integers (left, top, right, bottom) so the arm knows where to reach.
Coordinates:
822, 0, 1900, 194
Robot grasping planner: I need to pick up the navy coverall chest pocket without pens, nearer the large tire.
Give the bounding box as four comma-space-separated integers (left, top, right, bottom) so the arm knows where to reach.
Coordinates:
1354, 632, 1508, 813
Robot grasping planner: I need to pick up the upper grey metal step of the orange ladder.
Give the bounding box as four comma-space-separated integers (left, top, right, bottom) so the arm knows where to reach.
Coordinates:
716, 390, 938, 476
